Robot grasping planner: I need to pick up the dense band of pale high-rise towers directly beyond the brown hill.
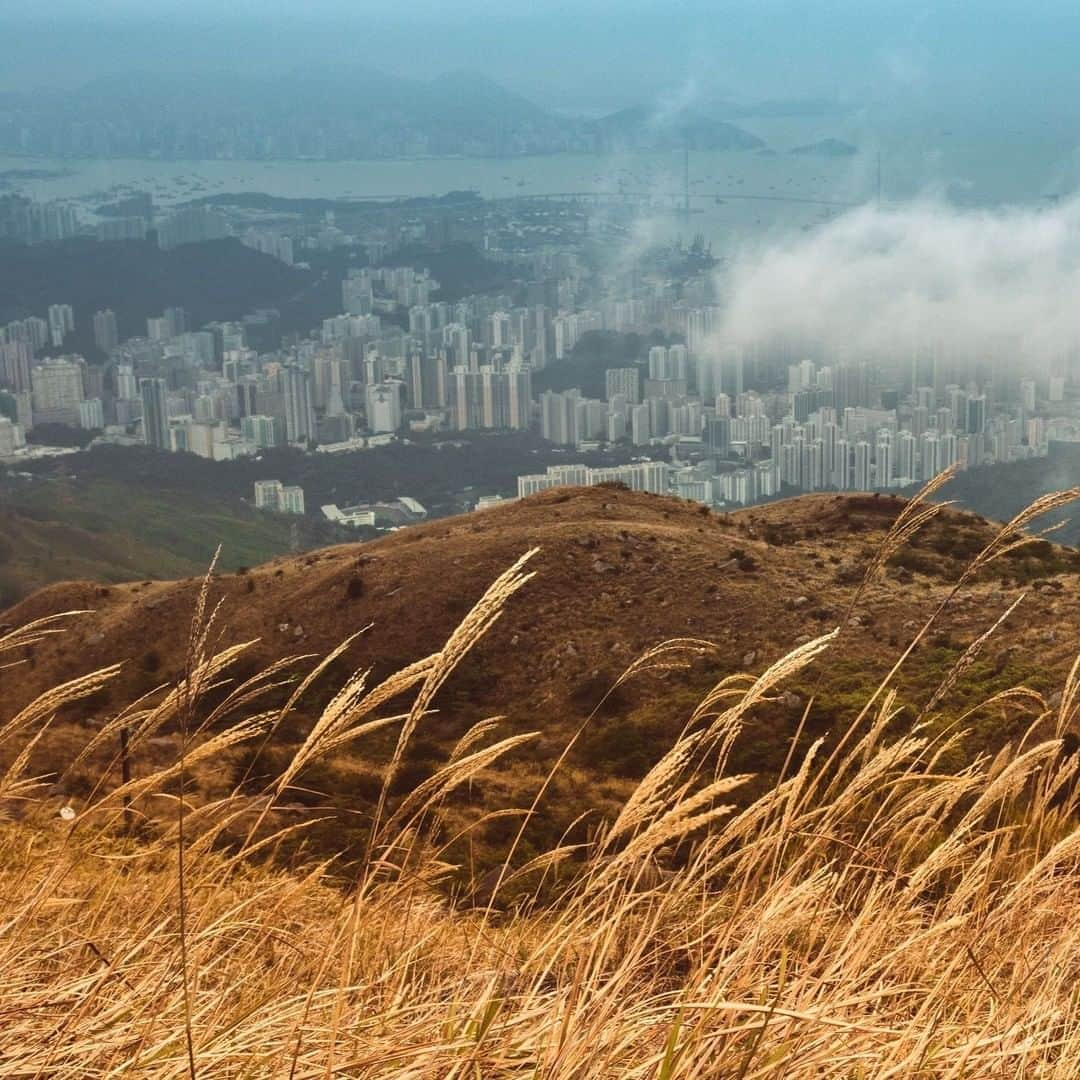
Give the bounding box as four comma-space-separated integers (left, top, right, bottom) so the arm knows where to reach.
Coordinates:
0, 196, 1080, 520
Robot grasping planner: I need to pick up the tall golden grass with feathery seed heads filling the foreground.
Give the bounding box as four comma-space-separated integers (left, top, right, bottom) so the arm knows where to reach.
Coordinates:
0, 492, 1080, 1080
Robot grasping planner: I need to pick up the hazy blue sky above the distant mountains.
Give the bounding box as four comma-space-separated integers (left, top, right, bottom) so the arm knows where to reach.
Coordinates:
6, 0, 1080, 112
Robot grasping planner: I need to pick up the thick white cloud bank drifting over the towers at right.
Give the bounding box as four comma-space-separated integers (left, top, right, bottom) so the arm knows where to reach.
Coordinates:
718, 197, 1080, 375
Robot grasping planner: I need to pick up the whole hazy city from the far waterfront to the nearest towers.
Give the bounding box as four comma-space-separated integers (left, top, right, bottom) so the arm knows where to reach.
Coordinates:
0, 186, 1080, 524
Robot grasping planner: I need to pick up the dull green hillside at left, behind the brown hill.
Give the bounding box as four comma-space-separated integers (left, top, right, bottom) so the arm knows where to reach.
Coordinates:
0, 474, 307, 608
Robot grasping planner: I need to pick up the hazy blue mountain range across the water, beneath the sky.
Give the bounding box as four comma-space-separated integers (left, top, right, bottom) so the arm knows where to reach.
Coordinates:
0, 67, 762, 160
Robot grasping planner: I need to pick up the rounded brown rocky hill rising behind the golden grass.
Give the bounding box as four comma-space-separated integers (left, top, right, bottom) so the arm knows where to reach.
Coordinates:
0, 488, 1080, 879
